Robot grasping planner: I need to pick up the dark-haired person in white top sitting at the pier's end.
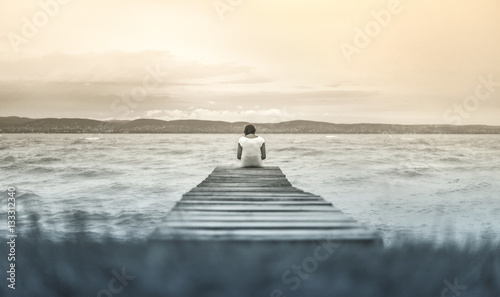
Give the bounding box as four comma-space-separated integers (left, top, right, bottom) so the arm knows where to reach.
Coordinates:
237, 125, 266, 167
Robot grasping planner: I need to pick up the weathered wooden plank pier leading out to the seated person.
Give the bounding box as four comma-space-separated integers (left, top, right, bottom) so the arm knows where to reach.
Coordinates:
154, 167, 381, 244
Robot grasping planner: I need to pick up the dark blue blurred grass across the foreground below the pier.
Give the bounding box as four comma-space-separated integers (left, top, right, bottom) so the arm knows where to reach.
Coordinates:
0, 213, 500, 297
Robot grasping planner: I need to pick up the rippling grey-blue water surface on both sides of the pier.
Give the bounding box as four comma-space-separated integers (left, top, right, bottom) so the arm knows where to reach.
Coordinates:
0, 134, 500, 244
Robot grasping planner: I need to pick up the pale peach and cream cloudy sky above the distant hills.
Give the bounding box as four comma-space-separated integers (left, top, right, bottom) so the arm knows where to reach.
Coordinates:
0, 0, 500, 125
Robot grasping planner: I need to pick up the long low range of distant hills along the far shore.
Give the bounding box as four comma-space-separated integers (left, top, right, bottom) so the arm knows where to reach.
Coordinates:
0, 117, 500, 134
